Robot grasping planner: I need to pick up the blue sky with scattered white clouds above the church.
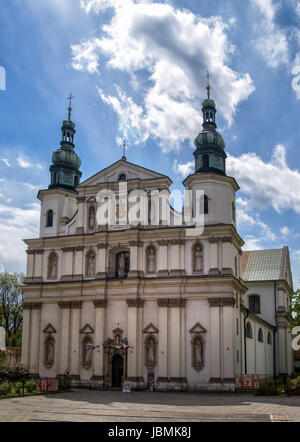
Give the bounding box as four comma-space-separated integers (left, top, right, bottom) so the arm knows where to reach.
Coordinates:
0, 0, 300, 287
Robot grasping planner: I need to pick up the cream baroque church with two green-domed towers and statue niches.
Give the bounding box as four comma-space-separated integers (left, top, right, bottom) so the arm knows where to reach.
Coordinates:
22, 88, 293, 391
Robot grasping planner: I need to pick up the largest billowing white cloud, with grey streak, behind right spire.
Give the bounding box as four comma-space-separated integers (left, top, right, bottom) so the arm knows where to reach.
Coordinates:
72, 0, 254, 150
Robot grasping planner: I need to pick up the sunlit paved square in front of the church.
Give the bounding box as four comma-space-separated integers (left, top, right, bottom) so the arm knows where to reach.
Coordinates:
0, 390, 300, 422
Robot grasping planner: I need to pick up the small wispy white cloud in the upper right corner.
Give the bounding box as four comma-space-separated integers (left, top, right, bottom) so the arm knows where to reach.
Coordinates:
252, 0, 290, 68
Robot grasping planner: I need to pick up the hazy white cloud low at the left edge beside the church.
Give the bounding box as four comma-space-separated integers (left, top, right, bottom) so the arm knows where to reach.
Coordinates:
0, 204, 40, 272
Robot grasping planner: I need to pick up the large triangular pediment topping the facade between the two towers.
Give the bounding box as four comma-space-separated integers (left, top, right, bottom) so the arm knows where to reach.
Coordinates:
78, 160, 171, 188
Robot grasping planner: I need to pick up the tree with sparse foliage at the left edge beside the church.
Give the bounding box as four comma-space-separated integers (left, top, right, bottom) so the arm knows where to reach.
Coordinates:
0, 272, 24, 347
